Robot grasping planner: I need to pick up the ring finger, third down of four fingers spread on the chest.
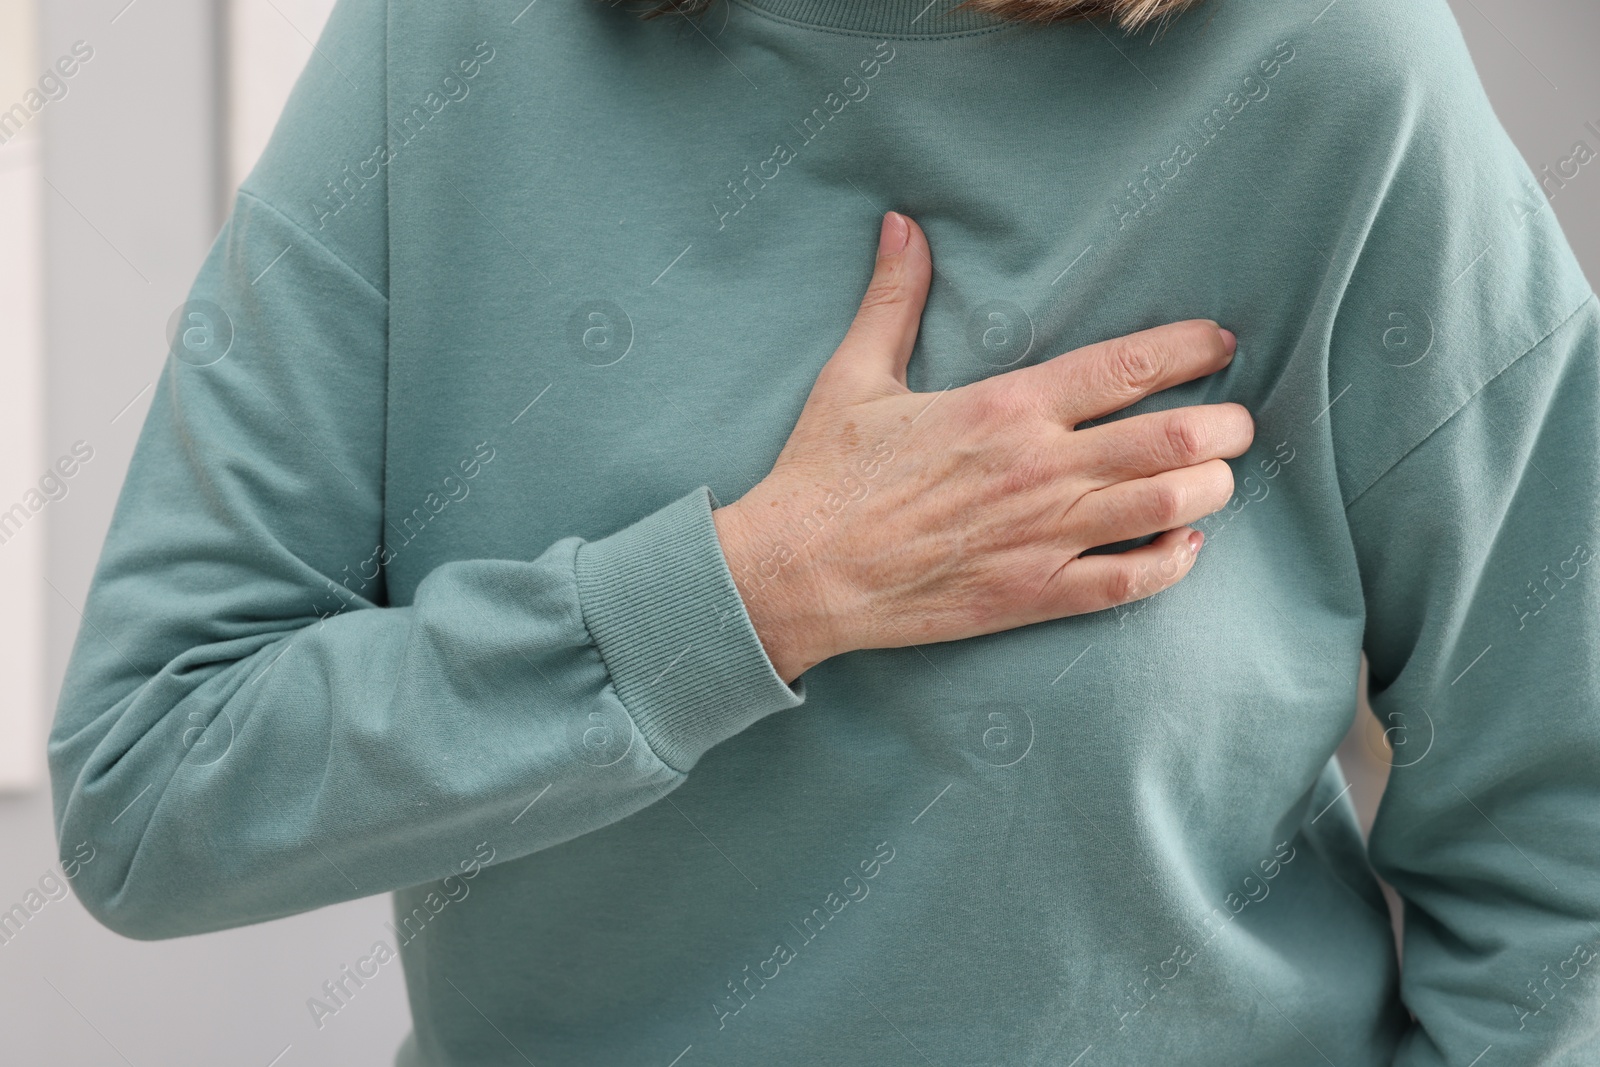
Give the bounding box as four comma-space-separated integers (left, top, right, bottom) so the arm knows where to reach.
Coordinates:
1067, 459, 1234, 550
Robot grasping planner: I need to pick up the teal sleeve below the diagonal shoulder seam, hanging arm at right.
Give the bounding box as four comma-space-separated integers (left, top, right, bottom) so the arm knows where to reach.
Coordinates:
1349, 299, 1600, 1067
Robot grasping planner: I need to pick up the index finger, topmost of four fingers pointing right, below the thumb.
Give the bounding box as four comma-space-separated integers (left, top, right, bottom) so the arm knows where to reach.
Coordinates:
1011, 318, 1238, 427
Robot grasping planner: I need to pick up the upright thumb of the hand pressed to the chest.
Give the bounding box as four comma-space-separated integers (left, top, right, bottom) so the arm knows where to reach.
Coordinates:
829, 211, 933, 387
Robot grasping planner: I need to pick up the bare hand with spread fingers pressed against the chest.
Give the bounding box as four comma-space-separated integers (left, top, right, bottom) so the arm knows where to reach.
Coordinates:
712, 211, 1254, 681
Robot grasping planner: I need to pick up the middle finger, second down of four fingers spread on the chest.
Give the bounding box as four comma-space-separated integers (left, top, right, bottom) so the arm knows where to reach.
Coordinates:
1072, 403, 1256, 486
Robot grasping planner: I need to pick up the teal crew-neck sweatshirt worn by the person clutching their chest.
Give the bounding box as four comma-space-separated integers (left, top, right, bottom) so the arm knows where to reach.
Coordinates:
50, 0, 1600, 1067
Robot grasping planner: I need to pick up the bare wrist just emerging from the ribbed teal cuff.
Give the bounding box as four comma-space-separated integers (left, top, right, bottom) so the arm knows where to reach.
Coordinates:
710, 496, 845, 683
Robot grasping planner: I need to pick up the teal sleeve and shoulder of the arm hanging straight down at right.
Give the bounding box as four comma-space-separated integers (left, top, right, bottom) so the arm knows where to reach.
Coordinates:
1304, 0, 1600, 1067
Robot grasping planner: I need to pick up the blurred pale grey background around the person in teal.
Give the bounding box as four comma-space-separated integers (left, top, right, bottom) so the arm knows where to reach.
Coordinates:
0, 0, 1600, 1067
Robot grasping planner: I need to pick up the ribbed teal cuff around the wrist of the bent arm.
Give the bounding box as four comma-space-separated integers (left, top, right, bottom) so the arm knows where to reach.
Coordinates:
578, 486, 805, 771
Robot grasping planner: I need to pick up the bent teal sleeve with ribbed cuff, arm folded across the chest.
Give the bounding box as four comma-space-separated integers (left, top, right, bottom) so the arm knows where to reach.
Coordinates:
50, 0, 803, 939
